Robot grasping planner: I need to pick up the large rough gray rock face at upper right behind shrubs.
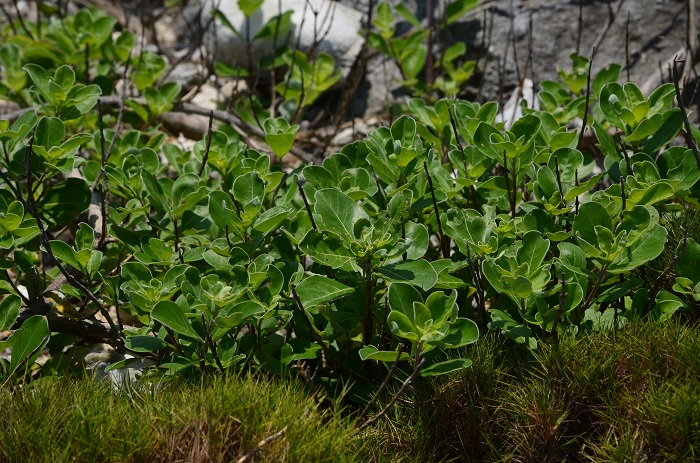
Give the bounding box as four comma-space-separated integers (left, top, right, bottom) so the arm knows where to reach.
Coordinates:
450, 0, 697, 102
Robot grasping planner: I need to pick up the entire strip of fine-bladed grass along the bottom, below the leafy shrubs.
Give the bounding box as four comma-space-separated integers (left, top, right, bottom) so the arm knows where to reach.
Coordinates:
0, 317, 700, 462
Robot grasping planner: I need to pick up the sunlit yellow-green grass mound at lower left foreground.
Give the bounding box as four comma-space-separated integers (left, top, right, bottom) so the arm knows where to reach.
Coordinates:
0, 378, 359, 462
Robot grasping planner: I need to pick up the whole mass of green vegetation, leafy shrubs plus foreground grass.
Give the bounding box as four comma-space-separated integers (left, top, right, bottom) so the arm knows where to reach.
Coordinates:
0, 1, 700, 461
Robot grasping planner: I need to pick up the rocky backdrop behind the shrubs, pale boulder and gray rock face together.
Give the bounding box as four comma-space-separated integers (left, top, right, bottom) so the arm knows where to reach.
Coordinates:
174, 0, 698, 116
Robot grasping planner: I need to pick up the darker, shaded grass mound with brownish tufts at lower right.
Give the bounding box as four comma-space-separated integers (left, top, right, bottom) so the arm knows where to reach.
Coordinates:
365, 321, 700, 462
